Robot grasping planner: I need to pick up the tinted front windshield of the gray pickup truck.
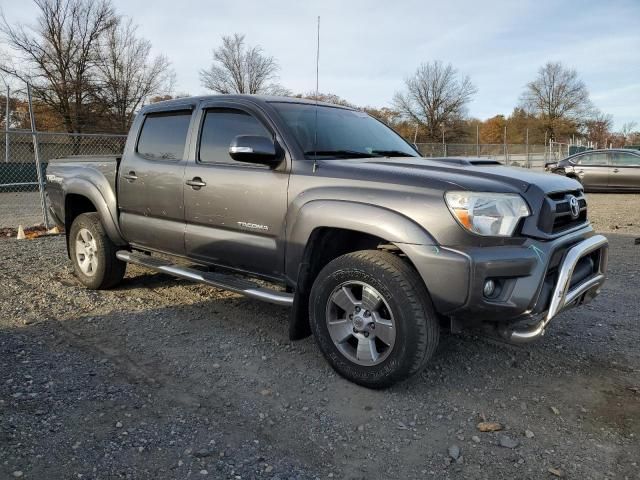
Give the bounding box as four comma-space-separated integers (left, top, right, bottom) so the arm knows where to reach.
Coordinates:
272, 102, 419, 159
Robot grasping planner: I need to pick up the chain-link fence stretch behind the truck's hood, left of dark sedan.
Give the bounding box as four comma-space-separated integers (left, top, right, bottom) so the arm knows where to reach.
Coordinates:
416, 142, 569, 170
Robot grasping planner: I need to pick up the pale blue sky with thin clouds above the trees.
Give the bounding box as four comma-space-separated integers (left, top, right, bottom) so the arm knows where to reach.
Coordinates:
0, 0, 640, 129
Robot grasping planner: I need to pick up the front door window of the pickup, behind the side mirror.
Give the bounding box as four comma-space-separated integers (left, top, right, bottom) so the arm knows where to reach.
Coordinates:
198, 108, 273, 164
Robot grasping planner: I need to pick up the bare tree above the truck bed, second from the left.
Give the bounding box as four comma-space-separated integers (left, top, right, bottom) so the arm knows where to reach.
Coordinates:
95, 19, 174, 132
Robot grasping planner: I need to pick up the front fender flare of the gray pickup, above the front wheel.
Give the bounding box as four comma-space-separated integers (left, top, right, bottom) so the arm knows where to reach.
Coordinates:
285, 200, 436, 281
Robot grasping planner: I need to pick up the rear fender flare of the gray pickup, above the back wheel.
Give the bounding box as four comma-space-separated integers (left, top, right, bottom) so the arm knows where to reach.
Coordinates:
64, 177, 127, 245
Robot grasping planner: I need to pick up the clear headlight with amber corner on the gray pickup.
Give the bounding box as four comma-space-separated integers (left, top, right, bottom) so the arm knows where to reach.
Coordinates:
445, 192, 531, 237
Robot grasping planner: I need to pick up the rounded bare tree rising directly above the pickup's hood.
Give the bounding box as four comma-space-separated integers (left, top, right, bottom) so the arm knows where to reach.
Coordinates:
393, 61, 477, 141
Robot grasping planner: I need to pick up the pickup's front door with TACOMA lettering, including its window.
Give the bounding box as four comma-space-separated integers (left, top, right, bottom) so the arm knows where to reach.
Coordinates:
184, 102, 289, 277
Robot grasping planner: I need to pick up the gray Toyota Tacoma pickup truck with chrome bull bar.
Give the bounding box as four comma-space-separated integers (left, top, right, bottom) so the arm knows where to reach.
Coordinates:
47, 95, 608, 388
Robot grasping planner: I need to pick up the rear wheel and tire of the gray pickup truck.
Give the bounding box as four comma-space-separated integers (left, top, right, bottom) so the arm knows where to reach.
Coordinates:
69, 212, 127, 290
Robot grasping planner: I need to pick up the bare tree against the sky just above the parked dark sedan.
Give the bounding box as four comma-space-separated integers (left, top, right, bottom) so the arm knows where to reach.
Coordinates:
521, 62, 593, 139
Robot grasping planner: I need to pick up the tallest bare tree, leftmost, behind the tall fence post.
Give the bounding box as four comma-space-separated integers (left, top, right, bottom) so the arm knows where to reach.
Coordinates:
0, 0, 117, 132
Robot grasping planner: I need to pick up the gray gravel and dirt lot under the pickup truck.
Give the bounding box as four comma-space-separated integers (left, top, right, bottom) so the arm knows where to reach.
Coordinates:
0, 195, 640, 479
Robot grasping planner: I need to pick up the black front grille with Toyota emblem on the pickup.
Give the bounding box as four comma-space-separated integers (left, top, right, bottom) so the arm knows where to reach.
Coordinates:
538, 190, 587, 235
